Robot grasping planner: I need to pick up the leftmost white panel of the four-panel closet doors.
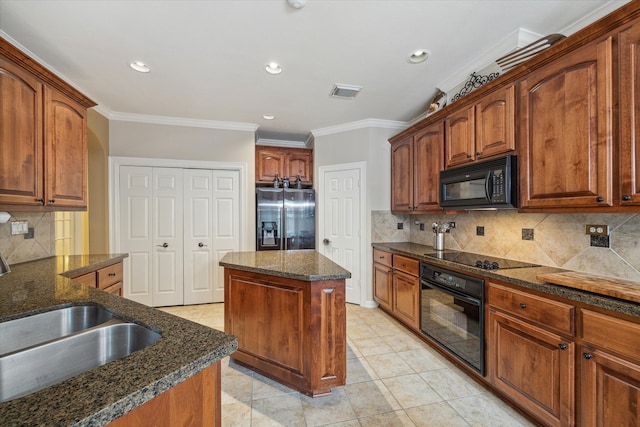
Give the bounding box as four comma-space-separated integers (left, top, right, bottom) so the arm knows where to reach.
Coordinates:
118, 166, 153, 305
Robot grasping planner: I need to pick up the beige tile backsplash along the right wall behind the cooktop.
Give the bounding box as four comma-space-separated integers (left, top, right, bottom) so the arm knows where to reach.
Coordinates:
371, 210, 640, 281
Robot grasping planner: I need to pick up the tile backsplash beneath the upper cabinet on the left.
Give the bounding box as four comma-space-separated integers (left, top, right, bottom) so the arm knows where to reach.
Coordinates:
0, 212, 55, 265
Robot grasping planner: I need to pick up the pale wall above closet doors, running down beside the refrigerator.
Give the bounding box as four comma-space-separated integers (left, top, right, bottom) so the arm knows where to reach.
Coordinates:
109, 120, 255, 250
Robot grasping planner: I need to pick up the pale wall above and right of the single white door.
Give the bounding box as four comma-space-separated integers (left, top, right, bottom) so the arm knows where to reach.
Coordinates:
313, 127, 400, 304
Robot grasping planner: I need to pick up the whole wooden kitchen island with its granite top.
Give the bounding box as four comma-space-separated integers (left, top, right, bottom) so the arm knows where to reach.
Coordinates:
220, 250, 351, 397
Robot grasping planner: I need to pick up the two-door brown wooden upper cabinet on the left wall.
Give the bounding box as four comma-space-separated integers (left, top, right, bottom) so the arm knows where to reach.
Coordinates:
0, 38, 95, 210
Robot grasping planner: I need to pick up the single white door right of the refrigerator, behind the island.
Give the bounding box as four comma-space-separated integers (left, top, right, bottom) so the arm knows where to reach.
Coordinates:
318, 164, 365, 304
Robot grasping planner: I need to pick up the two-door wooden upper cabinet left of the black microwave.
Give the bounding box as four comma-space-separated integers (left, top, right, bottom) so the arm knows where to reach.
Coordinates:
391, 121, 444, 214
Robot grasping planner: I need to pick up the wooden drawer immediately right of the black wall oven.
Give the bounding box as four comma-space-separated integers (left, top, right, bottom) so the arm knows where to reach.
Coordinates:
488, 283, 575, 335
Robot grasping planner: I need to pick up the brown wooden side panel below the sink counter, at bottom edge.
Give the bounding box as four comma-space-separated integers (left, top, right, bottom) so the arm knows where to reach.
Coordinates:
108, 362, 222, 427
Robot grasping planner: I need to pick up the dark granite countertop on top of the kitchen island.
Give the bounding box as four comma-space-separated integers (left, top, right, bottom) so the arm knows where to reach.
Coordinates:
220, 250, 351, 282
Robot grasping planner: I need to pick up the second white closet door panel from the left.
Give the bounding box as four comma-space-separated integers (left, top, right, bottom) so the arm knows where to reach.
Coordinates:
151, 168, 184, 307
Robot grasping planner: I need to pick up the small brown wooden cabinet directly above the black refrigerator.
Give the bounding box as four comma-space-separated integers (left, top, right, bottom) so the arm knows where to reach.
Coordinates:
256, 145, 313, 187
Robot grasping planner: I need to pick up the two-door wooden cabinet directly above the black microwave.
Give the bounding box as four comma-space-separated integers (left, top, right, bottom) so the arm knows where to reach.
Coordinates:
445, 85, 516, 168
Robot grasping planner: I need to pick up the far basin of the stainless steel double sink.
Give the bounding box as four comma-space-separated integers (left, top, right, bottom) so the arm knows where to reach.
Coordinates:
0, 305, 113, 356
